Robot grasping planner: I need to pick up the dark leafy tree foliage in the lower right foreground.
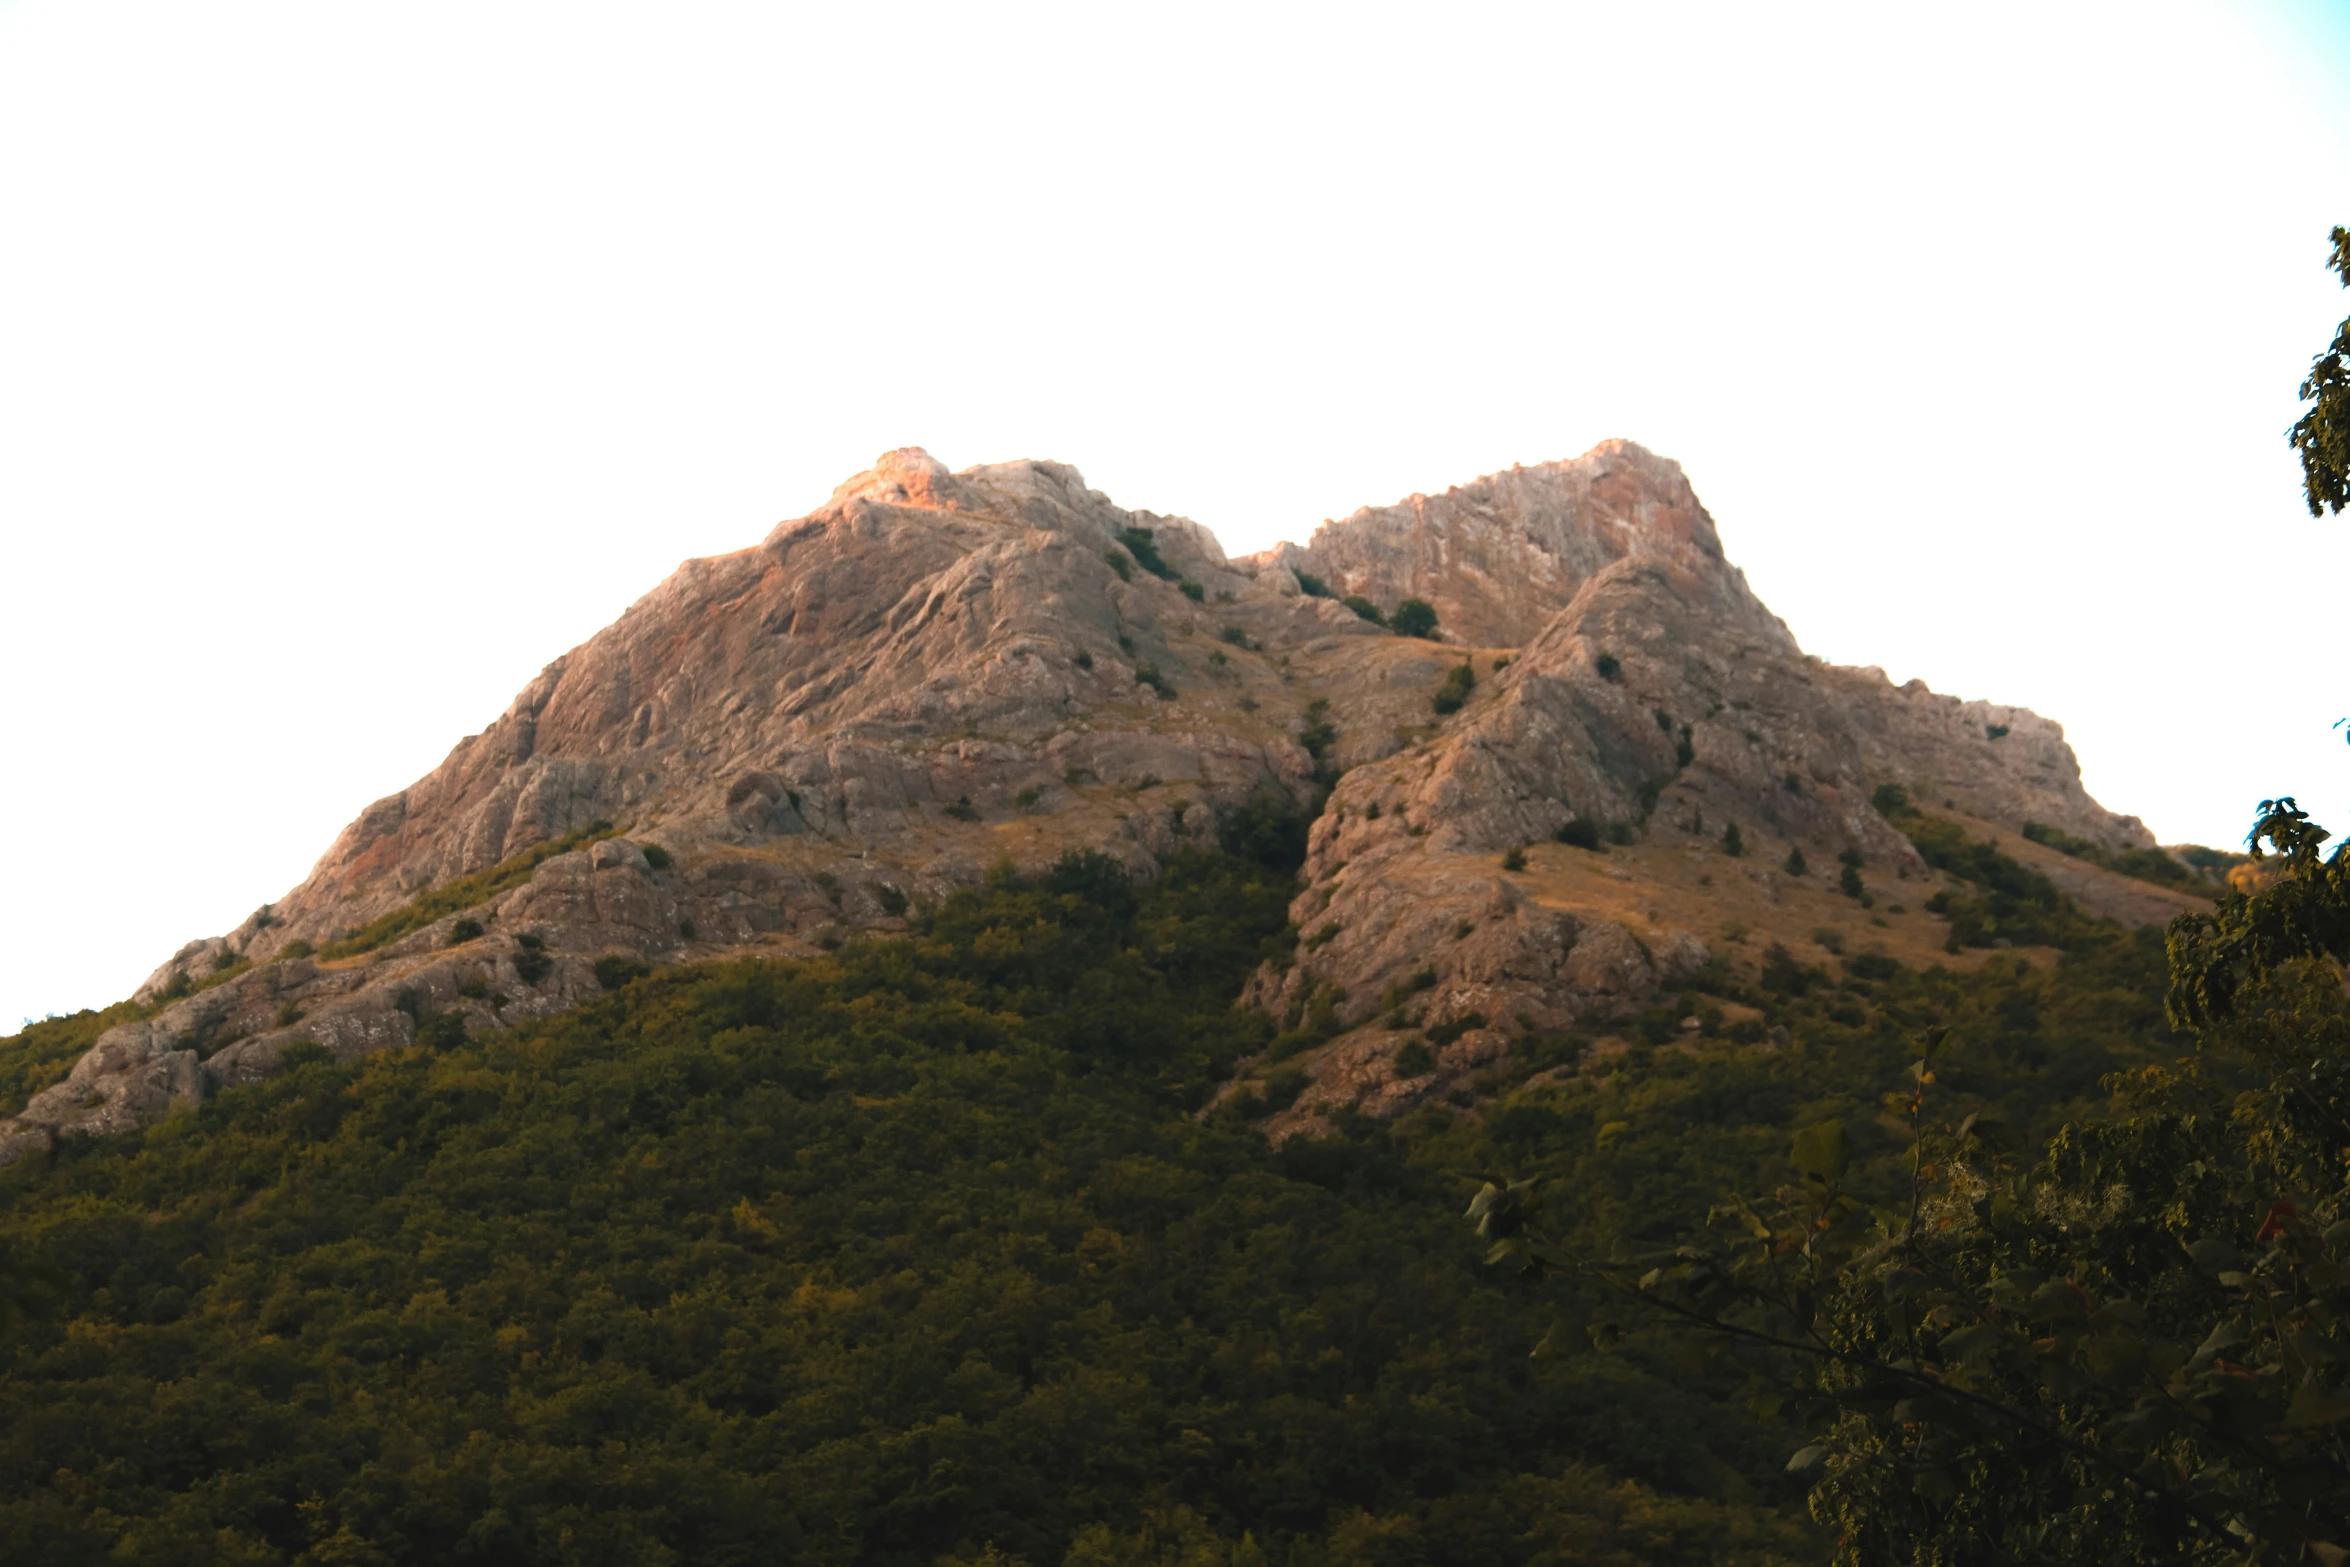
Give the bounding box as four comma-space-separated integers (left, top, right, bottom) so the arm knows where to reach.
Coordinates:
1471, 801, 2350, 1567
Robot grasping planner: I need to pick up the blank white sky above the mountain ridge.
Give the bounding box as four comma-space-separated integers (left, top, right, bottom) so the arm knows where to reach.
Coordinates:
0, 0, 2350, 1027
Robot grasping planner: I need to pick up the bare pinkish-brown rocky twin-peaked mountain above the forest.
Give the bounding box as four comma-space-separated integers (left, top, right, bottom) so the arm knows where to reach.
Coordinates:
0, 442, 2150, 1163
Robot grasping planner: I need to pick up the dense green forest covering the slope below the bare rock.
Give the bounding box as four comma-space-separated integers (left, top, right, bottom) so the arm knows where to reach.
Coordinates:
0, 817, 2178, 1567
